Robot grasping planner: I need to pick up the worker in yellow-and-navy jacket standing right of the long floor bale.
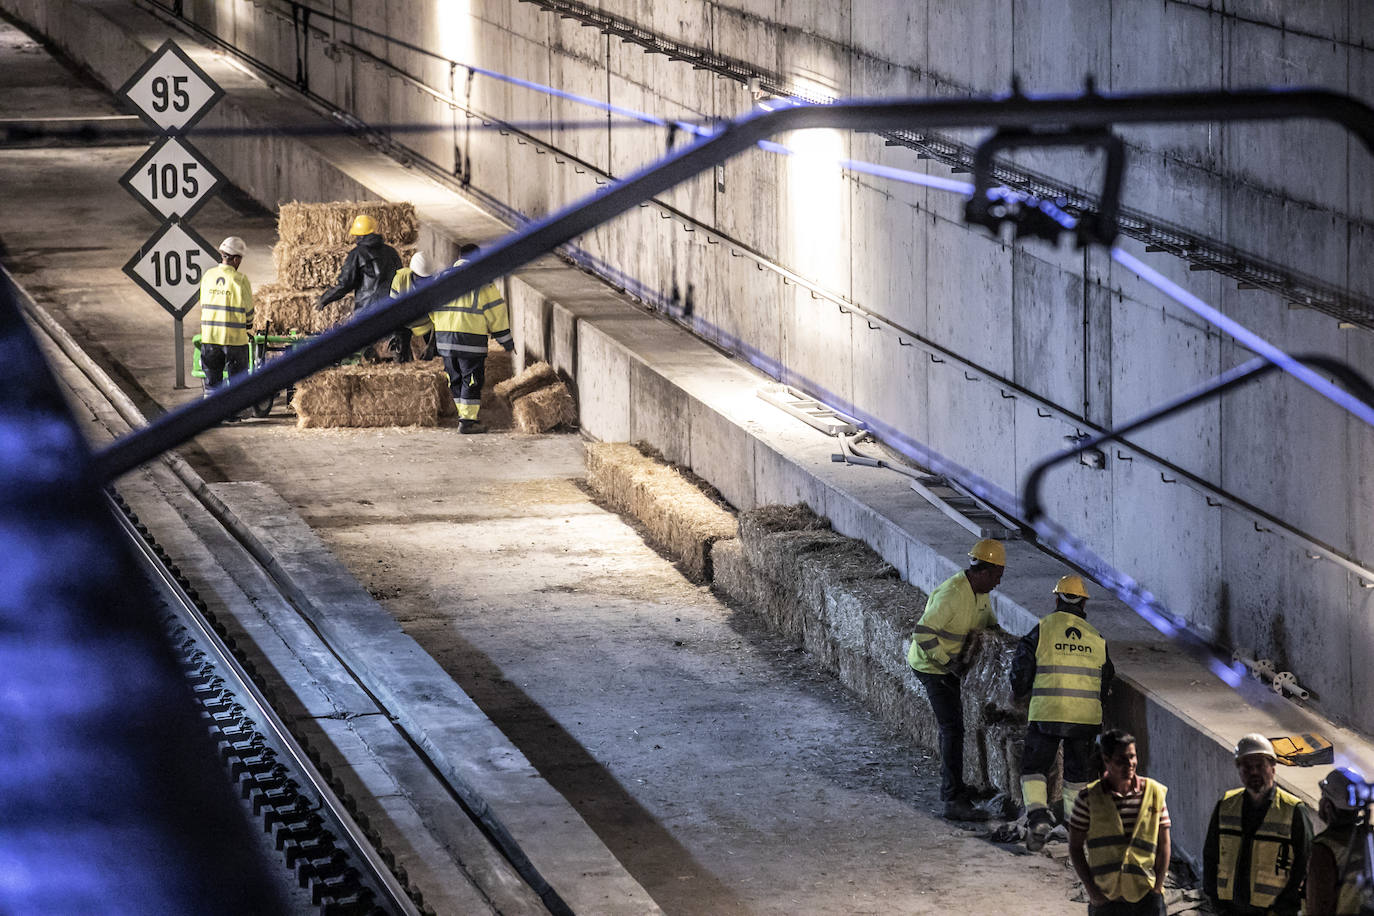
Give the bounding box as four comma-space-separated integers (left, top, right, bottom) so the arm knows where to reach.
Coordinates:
411, 244, 515, 433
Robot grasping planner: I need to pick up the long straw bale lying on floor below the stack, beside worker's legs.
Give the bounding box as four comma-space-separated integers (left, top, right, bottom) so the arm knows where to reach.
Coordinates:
291, 363, 448, 428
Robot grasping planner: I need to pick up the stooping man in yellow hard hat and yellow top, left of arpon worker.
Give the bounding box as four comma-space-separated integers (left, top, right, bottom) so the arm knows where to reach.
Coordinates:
907, 538, 1007, 820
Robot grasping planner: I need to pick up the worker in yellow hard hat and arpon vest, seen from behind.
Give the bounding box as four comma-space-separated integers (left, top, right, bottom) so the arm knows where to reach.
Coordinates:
1011, 575, 1114, 853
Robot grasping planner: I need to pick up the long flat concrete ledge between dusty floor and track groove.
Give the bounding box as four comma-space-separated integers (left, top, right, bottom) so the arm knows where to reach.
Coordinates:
210, 483, 660, 915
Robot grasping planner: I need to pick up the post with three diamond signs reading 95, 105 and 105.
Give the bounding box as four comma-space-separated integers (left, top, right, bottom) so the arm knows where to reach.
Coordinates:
118, 40, 225, 389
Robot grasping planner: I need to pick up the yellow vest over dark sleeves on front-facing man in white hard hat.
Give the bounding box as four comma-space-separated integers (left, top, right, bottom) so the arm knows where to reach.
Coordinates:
1216, 786, 1303, 909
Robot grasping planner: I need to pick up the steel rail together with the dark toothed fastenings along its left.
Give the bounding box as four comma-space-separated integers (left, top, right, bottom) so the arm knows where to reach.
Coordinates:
110, 494, 420, 916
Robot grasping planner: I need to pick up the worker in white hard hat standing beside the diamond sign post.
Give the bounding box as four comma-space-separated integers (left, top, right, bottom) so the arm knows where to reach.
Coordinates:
201, 235, 253, 419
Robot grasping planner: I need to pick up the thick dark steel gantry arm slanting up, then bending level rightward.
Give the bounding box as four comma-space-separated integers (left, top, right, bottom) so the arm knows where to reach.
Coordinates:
95, 89, 1374, 482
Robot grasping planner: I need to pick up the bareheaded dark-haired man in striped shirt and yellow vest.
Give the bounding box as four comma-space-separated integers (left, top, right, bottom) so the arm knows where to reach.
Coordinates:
1069, 728, 1172, 916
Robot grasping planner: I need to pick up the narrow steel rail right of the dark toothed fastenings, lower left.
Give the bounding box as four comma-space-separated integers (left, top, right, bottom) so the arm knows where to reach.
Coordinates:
104, 493, 420, 916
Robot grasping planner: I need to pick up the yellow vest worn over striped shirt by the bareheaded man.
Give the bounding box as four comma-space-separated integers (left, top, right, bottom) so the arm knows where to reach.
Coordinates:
1080, 776, 1169, 904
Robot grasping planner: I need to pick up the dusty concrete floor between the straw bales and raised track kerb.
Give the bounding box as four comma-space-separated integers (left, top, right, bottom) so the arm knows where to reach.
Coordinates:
0, 16, 1093, 913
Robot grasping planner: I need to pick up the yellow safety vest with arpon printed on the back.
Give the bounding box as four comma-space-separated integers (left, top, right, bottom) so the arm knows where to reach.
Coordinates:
1031, 611, 1107, 725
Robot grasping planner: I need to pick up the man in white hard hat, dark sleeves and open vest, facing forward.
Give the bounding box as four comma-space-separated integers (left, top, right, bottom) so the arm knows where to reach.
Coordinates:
1202, 735, 1312, 916
